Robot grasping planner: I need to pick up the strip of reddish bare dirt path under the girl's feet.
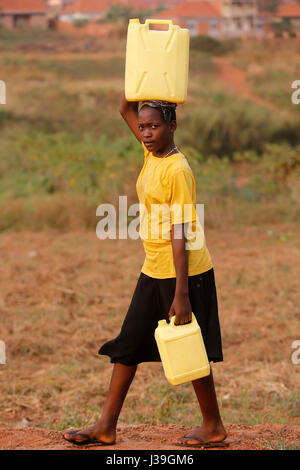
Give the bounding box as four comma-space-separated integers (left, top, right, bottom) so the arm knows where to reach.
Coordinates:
0, 424, 300, 450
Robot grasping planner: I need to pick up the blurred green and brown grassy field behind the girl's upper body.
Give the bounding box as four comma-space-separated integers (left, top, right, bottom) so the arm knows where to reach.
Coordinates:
0, 30, 300, 231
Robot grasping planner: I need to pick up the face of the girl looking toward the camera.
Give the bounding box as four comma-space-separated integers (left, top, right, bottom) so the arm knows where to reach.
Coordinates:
138, 106, 176, 154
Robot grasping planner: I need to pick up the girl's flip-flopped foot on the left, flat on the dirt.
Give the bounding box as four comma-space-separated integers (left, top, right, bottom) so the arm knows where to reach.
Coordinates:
62, 423, 116, 445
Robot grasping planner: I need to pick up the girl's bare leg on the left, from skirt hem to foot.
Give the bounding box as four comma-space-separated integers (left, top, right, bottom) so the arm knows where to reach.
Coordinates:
62, 363, 137, 443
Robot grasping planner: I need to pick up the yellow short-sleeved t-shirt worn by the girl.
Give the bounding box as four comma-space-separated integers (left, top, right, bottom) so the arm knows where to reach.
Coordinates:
136, 143, 213, 279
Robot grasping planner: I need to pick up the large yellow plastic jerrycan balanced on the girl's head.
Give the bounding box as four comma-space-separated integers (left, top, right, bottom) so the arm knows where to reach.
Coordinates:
125, 19, 189, 103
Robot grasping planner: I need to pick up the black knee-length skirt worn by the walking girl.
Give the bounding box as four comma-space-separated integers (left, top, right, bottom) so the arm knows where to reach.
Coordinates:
99, 268, 223, 366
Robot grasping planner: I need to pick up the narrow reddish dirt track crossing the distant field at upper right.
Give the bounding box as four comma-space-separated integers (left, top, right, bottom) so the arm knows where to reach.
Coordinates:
214, 57, 278, 111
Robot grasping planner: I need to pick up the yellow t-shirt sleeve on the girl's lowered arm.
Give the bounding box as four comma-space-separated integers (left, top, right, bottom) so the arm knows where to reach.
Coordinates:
170, 170, 197, 225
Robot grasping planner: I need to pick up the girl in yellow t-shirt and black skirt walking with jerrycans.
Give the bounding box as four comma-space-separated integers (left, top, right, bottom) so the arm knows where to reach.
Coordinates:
62, 92, 228, 447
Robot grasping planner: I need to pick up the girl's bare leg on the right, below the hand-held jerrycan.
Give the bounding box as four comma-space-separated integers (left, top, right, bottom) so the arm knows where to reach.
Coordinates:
175, 370, 227, 445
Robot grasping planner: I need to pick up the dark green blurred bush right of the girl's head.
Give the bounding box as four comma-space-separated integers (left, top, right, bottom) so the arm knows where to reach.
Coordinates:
178, 99, 300, 159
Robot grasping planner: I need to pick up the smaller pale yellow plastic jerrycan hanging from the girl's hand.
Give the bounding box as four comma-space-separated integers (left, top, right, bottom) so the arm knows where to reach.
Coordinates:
155, 314, 210, 385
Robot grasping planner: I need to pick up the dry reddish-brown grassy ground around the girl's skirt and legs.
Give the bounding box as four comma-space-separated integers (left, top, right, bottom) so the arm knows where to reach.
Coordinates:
0, 228, 300, 451
